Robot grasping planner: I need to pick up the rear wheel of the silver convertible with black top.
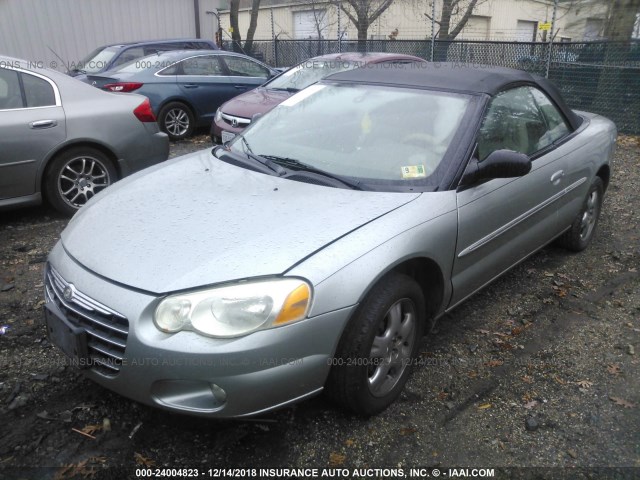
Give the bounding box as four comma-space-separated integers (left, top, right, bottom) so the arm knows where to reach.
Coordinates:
557, 177, 604, 252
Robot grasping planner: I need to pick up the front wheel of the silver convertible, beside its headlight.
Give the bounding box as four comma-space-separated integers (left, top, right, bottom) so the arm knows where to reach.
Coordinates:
325, 273, 426, 416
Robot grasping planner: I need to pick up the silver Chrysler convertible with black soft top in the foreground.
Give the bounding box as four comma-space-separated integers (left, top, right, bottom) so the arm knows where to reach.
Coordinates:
45, 64, 616, 417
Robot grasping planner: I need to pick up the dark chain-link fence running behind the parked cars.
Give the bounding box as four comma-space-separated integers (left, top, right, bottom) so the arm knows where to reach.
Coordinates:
226, 40, 640, 134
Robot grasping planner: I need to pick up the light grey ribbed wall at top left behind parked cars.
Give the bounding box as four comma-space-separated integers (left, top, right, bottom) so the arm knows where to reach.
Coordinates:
0, 0, 220, 70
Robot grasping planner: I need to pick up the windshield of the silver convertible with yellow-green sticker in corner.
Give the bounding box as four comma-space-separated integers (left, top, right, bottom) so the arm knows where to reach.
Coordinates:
229, 84, 470, 190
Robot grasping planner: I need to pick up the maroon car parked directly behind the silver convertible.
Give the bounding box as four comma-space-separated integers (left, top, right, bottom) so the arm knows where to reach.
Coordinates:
211, 52, 426, 143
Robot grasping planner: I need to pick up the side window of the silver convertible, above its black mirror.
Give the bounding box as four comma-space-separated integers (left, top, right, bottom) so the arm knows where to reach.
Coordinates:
478, 87, 551, 161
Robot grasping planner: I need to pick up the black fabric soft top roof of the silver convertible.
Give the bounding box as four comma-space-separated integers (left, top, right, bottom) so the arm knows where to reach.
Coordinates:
325, 62, 582, 130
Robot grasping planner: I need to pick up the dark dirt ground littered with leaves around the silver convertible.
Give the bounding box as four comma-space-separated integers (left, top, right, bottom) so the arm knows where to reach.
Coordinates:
0, 136, 640, 479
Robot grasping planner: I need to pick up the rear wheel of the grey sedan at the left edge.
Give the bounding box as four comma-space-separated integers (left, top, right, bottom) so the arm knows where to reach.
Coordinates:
44, 147, 118, 216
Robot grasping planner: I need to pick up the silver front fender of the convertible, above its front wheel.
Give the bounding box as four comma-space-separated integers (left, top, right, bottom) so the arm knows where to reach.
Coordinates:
286, 191, 458, 317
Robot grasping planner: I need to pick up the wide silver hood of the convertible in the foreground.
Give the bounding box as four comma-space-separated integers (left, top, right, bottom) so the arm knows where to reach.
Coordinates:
62, 150, 419, 293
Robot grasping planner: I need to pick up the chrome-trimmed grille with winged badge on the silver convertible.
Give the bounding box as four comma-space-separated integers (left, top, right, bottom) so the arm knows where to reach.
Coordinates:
45, 265, 129, 376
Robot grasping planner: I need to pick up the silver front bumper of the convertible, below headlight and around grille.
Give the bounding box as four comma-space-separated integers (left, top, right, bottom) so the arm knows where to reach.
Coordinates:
47, 242, 354, 418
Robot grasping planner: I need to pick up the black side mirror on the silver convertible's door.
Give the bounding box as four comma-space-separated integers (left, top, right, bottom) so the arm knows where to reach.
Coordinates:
461, 150, 531, 185
